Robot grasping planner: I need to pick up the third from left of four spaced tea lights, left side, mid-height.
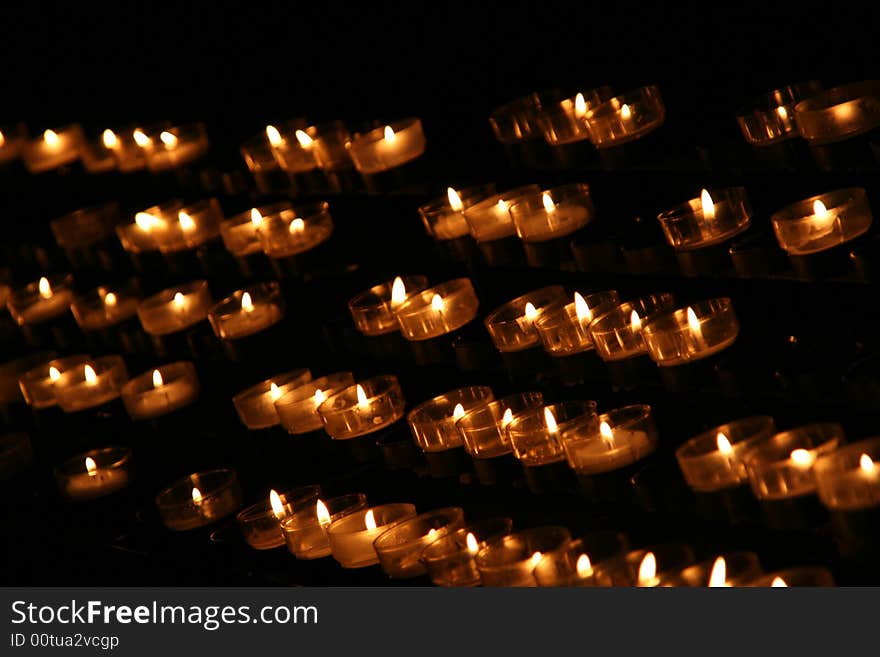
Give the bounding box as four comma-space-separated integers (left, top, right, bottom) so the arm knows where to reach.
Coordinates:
137, 281, 212, 335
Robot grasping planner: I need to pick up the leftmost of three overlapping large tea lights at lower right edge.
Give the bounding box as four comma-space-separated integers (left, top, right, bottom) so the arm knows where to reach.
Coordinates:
675, 415, 776, 493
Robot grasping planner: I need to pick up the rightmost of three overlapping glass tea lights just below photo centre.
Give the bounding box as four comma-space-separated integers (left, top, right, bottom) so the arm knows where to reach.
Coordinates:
318, 376, 406, 440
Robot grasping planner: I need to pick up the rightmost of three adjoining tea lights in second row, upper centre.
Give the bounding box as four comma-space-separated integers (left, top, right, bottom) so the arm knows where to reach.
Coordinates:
510, 183, 595, 242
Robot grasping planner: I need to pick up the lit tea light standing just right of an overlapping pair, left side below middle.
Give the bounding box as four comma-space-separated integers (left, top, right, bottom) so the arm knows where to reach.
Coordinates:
122, 361, 200, 420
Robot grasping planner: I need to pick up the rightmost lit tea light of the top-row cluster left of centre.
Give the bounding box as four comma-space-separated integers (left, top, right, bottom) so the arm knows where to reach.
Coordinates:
349, 118, 426, 174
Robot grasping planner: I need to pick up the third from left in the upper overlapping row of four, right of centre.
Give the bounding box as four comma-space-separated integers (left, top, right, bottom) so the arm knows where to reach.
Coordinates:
590, 292, 675, 361
